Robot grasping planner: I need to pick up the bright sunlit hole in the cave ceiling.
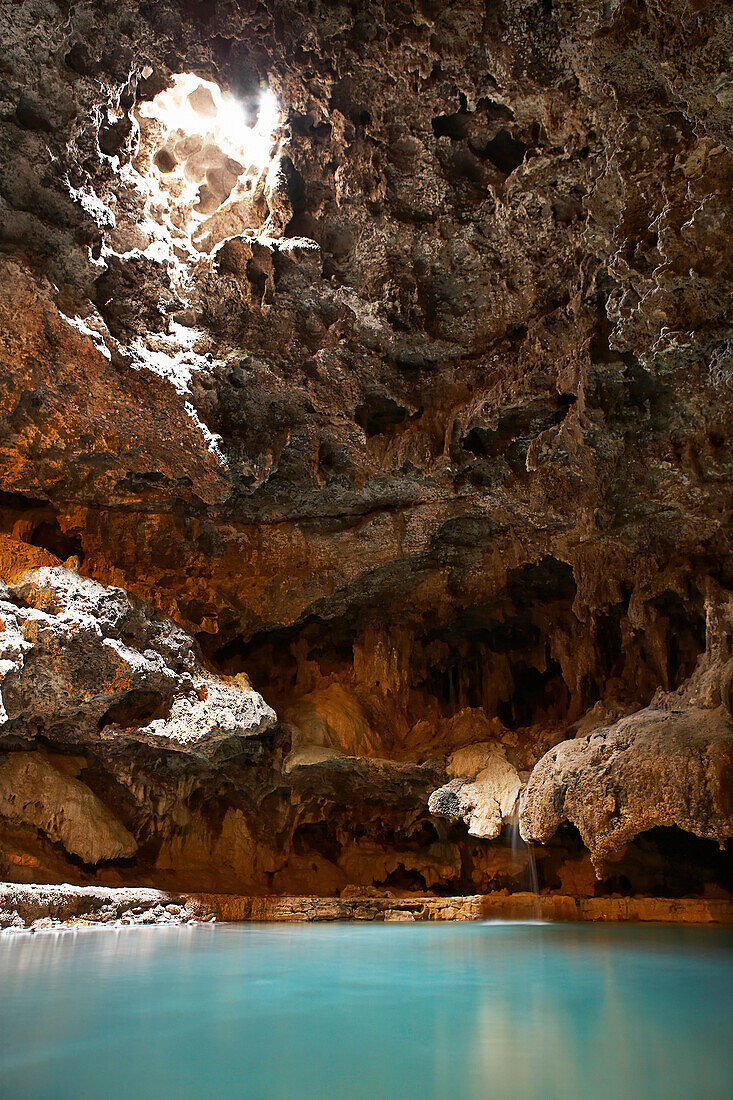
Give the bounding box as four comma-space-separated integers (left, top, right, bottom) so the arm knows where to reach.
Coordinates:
129, 73, 283, 252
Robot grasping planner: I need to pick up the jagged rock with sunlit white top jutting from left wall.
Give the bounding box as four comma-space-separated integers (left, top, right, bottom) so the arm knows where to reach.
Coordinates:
0, 567, 275, 754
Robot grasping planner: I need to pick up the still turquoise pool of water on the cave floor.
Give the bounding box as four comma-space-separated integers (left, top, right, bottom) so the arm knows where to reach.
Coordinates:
0, 924, 733, 1100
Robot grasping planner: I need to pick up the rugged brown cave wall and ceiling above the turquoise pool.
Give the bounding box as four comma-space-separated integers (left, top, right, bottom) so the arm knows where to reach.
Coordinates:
0, 0, 733, 895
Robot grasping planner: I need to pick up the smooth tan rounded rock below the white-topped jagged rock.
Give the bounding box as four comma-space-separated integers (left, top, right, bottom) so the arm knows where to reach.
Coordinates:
0, 752, 138, 864
